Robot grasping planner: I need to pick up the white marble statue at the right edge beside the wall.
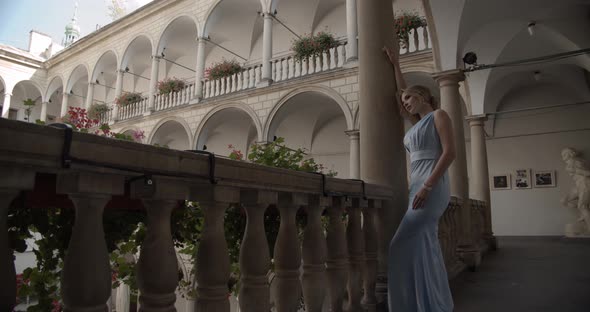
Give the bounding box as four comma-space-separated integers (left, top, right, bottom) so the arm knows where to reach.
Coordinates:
561, 148, 590, 237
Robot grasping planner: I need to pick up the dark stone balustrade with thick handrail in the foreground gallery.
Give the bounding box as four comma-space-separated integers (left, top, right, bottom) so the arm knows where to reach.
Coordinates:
0, 119, 490, 311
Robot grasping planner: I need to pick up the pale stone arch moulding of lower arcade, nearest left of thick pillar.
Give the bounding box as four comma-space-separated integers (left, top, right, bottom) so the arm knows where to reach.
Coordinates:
262, 86, 354, 140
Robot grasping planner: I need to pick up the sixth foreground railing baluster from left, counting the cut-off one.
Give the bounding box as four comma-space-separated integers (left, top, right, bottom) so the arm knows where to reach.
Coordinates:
274, 192, 307, 312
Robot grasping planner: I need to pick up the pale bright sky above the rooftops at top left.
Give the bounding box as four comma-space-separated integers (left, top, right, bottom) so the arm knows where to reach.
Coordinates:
0, 0, 152, 50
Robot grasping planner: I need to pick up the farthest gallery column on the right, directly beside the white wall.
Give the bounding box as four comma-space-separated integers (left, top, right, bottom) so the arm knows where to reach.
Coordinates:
467, 115, 495, 247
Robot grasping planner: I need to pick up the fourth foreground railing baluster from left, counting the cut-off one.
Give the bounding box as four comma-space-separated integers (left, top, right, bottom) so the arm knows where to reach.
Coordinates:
191, 186, 240, 312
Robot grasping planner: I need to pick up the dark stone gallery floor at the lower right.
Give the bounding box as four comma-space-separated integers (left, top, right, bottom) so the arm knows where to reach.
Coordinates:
451, 237, 590, 312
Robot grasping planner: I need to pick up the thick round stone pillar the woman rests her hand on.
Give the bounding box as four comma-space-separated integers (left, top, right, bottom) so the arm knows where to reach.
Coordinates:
357, 0, 408, 302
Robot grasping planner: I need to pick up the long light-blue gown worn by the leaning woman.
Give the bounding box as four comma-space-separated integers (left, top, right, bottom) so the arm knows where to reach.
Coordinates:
388, 112, 453, 312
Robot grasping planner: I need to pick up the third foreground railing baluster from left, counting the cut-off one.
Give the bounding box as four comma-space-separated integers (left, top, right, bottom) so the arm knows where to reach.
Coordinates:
137, 199, 178, 312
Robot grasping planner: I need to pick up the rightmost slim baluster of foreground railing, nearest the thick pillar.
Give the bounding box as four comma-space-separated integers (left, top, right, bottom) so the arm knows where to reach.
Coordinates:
363, 199, 381, 311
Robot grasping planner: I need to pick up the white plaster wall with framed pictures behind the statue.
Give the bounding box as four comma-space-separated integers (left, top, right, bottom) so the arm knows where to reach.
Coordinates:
465, 85, 590, 235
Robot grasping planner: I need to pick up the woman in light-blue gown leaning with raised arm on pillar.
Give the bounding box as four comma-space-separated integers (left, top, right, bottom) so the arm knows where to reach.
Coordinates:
384, 48, 455, 312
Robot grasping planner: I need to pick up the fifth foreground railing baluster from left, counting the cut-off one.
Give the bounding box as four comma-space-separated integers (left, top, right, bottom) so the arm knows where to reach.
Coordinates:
239, 190, 277, 312
